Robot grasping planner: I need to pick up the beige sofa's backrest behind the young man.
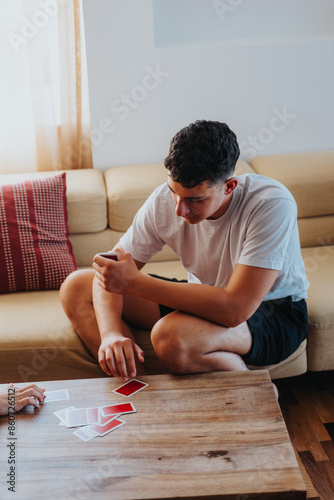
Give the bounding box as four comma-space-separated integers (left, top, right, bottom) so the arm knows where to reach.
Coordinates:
0, 151, 334, 267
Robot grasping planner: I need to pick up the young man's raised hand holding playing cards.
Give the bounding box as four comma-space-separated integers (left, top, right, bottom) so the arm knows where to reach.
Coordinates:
93, 249, 139, 294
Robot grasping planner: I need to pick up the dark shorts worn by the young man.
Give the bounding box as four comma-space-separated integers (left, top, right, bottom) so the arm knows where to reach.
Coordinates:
151, 274, 308, 366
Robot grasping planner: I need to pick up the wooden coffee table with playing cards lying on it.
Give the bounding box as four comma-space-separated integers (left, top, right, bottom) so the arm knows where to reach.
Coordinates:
0, 371, 306, 500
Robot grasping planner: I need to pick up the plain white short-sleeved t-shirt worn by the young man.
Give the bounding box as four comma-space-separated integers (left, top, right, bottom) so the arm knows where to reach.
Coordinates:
120, 174, 309, 300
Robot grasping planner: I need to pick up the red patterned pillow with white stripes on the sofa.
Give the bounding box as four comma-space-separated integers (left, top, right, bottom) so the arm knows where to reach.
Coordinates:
0, 173, 76, 293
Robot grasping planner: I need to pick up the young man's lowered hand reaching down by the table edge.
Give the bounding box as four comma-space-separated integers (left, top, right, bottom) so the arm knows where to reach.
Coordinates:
98, 333, 144, 382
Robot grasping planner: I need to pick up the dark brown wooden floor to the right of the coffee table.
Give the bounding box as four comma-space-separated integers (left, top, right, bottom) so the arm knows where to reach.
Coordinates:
277, 370, 334, 500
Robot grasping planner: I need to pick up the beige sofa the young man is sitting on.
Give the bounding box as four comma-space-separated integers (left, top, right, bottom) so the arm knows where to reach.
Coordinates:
0, 152, 334, 383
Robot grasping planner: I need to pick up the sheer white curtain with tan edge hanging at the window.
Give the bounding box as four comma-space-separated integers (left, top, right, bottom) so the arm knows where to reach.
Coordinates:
0, 0, 92, 173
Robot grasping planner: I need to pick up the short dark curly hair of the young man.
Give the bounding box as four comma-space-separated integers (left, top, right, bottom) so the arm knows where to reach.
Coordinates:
164, 120, 240, 188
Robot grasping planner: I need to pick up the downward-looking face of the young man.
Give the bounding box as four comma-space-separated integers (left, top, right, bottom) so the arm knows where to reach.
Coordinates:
167, 175, 237, 224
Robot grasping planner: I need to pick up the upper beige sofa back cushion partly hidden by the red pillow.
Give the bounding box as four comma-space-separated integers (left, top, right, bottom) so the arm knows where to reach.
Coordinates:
0, 169, 107, 234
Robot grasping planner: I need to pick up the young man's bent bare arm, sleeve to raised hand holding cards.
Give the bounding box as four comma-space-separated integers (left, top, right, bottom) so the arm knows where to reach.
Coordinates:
94, 253, 278, 327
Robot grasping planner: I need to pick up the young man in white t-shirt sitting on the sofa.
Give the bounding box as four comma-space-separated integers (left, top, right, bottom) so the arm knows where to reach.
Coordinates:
61, 121, 308, 388
